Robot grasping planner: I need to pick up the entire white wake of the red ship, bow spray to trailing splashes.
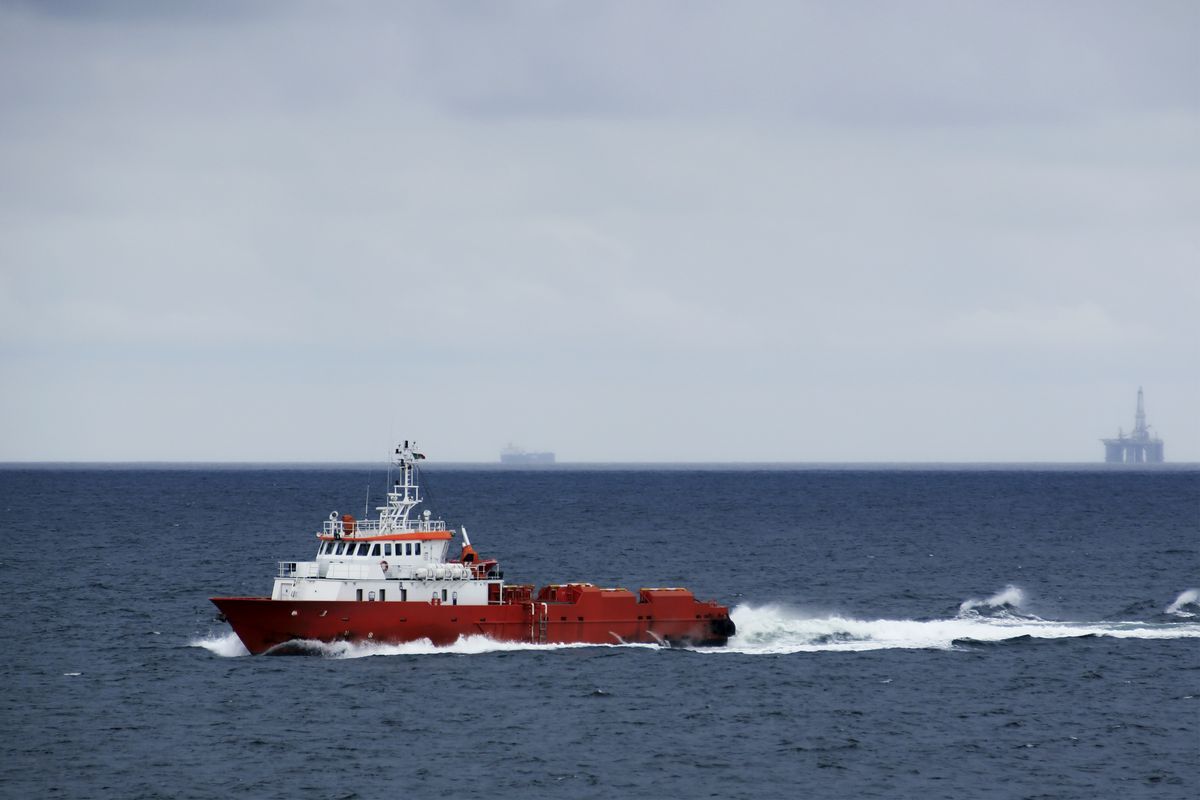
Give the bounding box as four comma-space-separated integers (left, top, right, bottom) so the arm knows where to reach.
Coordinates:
190, 585, 1200, 658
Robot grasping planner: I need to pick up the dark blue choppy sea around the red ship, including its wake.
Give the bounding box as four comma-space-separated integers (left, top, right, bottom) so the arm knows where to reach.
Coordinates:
0, 465, 1200, 799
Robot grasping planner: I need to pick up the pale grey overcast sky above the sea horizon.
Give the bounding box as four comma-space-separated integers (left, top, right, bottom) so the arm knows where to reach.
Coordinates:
0, 0, 1200, 462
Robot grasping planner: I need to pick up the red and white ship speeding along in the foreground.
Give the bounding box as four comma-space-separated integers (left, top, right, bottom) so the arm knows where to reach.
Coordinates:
211, 440, 736, 655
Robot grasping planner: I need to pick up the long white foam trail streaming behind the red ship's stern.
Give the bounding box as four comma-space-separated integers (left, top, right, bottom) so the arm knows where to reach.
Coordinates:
697, 604, 1200, 655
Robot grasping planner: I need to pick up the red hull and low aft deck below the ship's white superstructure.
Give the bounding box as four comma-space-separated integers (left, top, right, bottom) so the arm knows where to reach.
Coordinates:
212, 584, 733, 655
